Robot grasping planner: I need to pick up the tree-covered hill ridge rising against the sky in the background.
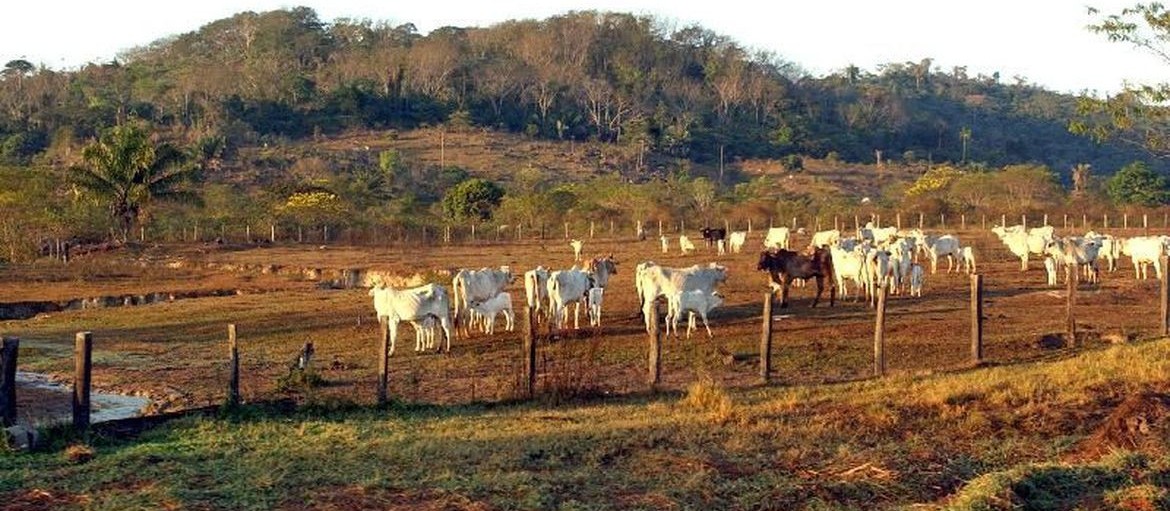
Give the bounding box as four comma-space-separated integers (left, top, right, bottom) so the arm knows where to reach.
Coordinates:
0, 7, 1143, 175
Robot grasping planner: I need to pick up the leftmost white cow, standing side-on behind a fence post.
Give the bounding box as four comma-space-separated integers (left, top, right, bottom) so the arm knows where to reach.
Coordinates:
370, 284, 452, 355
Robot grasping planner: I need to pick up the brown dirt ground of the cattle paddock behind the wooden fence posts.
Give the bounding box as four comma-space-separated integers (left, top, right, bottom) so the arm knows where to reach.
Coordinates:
0, 224, 1161, 417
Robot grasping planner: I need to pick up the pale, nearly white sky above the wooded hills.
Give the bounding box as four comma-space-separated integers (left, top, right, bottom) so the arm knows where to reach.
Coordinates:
0, 0, 1170, 94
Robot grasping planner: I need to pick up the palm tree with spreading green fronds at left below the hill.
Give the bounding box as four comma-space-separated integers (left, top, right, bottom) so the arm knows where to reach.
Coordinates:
70, 124, 195, 241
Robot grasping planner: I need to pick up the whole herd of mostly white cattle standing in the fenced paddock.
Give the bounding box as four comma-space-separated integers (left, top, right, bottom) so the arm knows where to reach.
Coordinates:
370, 223, 1170, 354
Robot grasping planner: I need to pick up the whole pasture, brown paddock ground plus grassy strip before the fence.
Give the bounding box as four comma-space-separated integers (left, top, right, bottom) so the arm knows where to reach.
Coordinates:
0, 224, 1170, 509
